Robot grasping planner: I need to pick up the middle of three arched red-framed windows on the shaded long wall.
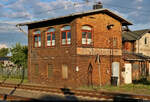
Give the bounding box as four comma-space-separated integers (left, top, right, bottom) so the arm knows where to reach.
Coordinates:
46, 28, 55, 47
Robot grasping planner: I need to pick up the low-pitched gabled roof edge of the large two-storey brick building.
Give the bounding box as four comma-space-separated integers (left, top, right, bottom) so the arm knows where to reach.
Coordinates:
17, 8, 132, 26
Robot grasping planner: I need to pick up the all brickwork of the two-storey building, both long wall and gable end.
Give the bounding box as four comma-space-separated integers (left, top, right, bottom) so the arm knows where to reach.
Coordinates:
28, 14, 122, 87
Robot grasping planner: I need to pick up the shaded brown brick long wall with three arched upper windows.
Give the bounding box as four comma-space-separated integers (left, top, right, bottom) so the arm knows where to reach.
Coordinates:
28, 21, 76, 87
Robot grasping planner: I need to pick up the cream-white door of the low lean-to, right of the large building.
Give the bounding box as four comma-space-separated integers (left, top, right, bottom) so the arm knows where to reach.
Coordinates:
124, 63, 132, 84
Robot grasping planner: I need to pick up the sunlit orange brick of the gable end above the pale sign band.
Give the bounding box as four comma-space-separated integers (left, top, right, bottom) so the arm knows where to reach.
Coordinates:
77, 14, 122, 49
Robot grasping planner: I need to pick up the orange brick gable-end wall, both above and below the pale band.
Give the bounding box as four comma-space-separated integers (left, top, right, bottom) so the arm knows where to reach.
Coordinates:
77, 14, 122, 85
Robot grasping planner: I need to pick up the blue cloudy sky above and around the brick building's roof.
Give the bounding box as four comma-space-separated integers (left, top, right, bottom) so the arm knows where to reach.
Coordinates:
0, 0, 150, 47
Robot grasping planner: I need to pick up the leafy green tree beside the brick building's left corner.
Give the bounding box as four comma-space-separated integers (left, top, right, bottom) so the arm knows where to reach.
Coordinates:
10, 43, 28, 68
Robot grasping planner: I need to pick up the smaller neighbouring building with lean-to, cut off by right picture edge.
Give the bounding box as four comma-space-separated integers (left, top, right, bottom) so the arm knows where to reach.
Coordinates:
122, 29, 150, 83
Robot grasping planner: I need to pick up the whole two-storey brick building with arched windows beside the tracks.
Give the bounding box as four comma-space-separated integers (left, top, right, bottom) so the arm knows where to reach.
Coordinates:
18, 8, 131, 87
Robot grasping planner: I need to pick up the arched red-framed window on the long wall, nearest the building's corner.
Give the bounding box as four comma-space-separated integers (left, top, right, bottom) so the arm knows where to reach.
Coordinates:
61, 26, 71, 45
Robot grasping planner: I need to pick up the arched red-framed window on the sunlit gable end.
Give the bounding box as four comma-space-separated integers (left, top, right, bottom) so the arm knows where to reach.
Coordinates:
82, 26, 92, 45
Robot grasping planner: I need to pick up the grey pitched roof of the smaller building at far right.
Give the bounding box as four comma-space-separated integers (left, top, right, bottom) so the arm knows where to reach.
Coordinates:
122, 29, 150, 41
